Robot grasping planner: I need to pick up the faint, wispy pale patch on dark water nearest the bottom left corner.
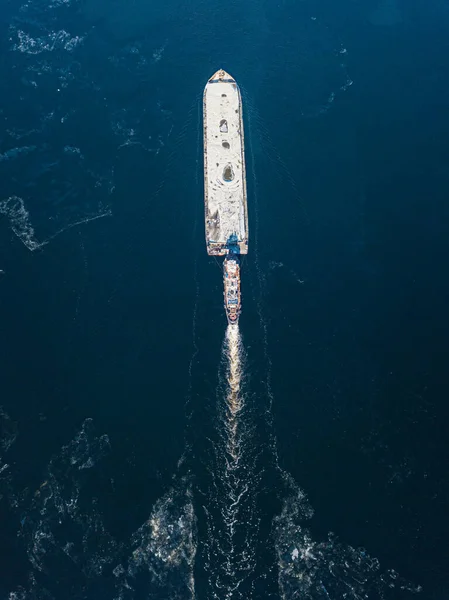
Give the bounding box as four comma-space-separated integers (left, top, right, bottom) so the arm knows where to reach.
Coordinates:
11, 419, 115, 575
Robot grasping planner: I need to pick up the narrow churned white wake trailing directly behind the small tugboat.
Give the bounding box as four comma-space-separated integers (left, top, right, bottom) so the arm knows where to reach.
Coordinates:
203, 325, 260, 600
